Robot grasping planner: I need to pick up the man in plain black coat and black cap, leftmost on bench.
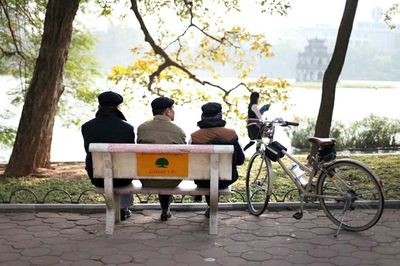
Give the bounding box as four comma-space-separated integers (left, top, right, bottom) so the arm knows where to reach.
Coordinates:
82, 91, 135, 220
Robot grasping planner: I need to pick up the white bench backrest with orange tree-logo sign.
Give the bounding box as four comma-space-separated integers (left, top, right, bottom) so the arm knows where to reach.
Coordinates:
89, 143, 233, 180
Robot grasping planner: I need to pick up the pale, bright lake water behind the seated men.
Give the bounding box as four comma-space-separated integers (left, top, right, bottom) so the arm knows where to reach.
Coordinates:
0, 76, 400, 163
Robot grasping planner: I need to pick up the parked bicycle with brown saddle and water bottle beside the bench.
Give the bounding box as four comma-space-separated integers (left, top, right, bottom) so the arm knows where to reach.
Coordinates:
246, 118, 384, 237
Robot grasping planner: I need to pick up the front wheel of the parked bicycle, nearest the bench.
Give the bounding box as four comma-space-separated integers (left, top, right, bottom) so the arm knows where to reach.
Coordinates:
246, 151, 271, 216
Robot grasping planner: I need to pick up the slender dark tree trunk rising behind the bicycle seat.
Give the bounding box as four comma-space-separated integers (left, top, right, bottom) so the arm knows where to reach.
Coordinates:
311, 0, 358, 155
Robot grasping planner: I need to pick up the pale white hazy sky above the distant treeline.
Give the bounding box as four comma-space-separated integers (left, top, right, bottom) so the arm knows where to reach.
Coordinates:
80, 0, 398, 32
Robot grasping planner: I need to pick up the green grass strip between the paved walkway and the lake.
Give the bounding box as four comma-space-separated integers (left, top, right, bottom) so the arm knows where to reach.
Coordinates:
0, 154, 400, 203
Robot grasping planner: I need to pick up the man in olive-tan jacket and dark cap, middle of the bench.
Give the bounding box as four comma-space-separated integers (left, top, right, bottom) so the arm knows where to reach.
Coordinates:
137, 97, 186, 221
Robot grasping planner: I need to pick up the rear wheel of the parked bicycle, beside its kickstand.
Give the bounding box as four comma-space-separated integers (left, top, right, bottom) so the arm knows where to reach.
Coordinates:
317, 159, 384, 231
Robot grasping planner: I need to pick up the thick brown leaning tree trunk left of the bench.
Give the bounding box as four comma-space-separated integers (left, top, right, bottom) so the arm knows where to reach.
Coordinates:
4, 0, 80, 177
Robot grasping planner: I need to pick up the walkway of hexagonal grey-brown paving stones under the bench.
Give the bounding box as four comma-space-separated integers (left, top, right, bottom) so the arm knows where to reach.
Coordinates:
0, 209, 400, 266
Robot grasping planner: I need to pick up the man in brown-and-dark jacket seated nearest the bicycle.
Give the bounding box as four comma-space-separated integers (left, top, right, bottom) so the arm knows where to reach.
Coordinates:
191, 102, 244, 217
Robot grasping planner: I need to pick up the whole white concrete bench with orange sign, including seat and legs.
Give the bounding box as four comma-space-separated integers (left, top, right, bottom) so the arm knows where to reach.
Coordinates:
89, 143, 233, 234
